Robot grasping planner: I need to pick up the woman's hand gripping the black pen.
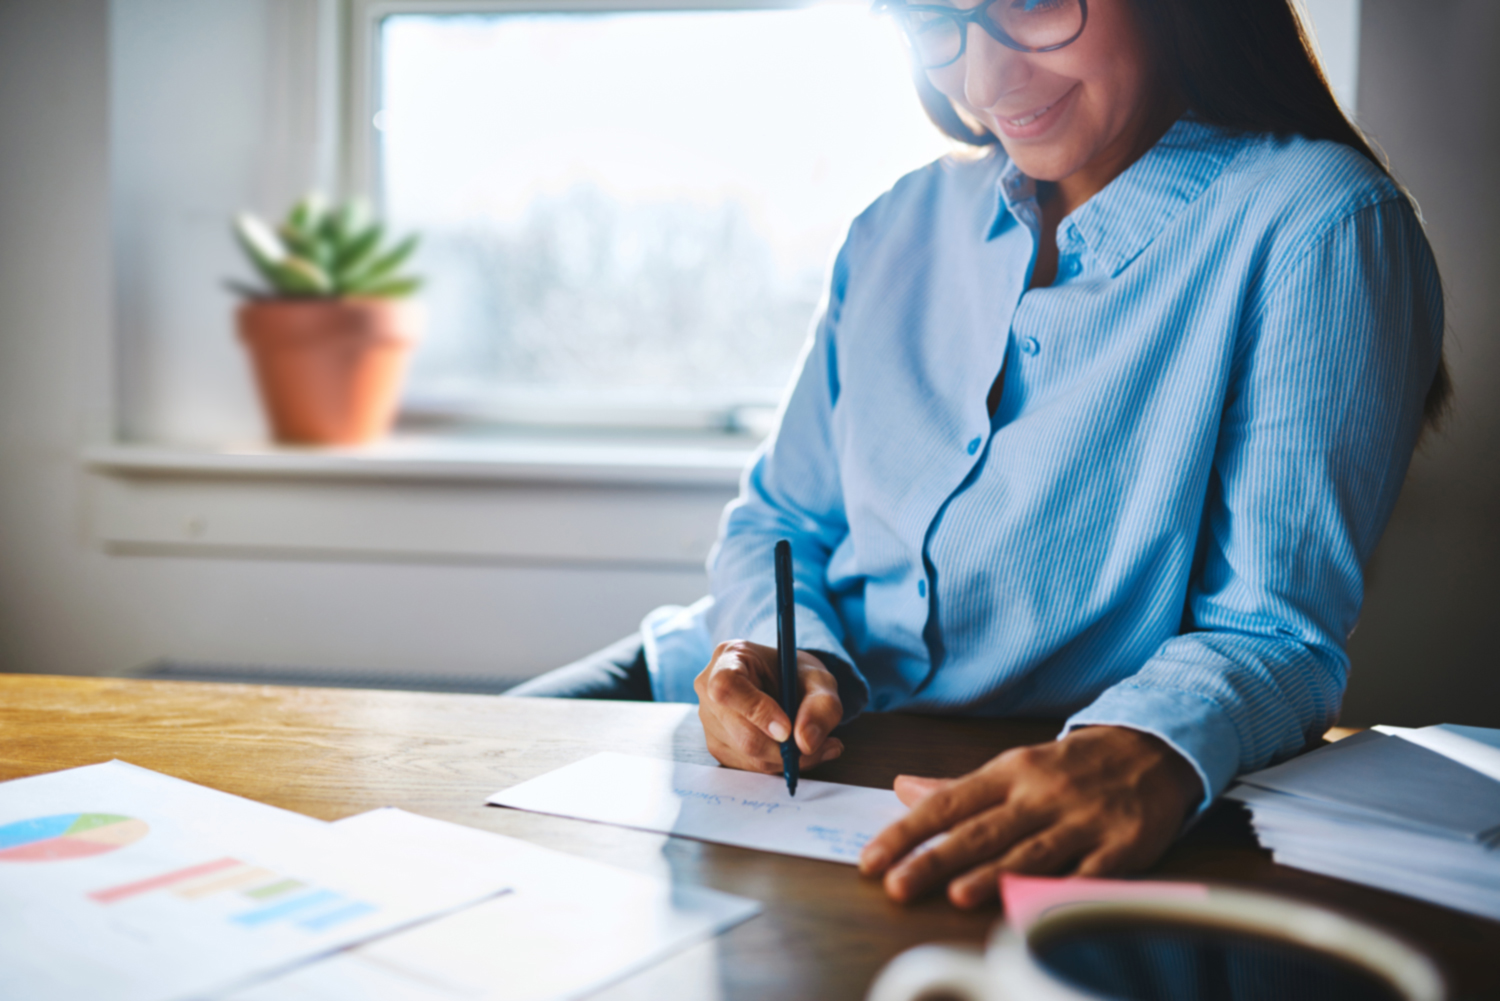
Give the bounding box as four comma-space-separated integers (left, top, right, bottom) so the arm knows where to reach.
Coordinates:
693, 639, 843, 774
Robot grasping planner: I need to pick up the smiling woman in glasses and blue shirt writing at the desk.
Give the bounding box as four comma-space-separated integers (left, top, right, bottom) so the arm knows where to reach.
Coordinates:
518, 0, 1448, 906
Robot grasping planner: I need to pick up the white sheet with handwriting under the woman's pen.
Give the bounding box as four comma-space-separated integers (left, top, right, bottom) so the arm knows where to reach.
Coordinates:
489, 753, 906, 864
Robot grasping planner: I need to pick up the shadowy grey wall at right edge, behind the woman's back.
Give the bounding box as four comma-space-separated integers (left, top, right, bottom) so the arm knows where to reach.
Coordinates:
1344, 0, 1500, 726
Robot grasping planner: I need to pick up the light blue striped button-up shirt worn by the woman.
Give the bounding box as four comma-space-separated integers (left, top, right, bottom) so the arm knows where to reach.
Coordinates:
645, 120, 1443, 803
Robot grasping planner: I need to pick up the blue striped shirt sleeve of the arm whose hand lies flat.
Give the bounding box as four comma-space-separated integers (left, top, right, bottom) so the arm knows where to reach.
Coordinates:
1064, 200, 1443, 809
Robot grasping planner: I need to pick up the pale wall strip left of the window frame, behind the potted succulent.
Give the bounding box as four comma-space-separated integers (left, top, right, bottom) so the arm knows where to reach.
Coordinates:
110, 0, 338, 443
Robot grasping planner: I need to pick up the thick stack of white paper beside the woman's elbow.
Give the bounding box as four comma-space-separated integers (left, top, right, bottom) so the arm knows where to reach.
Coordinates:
1227, 725, 1500, 920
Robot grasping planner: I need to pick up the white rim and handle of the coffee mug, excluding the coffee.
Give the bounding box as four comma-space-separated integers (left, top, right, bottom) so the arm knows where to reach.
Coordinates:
867, 887, 1448, 1001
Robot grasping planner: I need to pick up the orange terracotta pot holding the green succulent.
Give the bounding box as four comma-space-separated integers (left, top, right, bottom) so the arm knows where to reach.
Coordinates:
237, 299, 422, 444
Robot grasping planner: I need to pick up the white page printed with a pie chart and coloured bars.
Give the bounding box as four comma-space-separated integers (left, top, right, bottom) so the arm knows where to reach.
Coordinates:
0, 761, 506, 1001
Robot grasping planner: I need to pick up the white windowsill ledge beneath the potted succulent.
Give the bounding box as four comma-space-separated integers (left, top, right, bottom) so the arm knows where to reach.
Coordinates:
83, 432, 756, 488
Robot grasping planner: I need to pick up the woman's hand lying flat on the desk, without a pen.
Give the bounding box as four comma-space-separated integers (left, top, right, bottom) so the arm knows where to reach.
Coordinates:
860, 726, 1203, 908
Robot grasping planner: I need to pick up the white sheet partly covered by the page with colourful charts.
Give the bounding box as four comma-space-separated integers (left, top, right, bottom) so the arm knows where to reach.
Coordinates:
225, 809, 761, 1001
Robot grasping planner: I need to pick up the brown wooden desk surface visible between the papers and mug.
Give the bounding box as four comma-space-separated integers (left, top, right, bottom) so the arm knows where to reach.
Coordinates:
0, 675, 1500, 1001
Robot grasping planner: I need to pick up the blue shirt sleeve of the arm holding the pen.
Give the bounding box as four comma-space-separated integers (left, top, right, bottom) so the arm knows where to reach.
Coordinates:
708, 237, 870, 719
